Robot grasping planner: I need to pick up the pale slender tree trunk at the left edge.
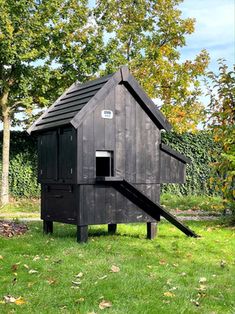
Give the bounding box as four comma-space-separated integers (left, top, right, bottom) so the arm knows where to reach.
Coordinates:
0, 93, 11, 205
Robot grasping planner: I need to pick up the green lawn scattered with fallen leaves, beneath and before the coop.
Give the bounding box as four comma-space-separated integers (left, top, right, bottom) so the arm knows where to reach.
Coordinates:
0, 221, 235, 314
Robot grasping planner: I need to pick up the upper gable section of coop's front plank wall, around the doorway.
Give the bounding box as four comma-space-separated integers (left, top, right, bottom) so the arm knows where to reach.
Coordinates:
77, 85, 160, 184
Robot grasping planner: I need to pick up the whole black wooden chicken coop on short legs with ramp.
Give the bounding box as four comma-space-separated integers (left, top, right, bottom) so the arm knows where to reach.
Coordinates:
28, 67, 196, 242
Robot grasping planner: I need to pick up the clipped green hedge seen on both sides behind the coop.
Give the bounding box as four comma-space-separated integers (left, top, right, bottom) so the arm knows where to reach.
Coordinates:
0, 131, 218, 198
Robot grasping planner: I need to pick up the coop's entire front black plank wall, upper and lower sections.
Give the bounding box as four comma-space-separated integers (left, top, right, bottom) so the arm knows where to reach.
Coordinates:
77, 85, 160, 224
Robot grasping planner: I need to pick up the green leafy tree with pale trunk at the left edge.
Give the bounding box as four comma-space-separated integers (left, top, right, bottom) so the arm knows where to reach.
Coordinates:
0, 0, 104, 204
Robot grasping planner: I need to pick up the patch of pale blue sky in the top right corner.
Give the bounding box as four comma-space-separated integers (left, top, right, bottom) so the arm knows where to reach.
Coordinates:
180, 0, 235, 71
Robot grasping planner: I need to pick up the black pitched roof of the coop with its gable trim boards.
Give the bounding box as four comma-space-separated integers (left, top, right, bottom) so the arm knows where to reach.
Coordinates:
28, 67, 171, 134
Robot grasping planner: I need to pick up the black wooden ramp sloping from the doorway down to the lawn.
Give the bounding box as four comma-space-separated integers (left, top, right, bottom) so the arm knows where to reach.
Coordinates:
96, 177, 199, 238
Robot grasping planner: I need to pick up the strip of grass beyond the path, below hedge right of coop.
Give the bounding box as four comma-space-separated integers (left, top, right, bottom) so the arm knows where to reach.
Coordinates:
161, 193, 223, 212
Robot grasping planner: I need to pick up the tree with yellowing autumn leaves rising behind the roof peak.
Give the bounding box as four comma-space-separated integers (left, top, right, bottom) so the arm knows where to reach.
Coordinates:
94, 0, 209, 132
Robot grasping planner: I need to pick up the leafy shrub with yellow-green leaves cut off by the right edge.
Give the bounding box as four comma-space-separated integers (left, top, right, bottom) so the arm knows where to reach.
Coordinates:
207, 59, 235, 214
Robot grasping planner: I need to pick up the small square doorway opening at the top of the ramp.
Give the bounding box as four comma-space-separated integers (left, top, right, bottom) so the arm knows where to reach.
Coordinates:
96, 151, 113, 177
